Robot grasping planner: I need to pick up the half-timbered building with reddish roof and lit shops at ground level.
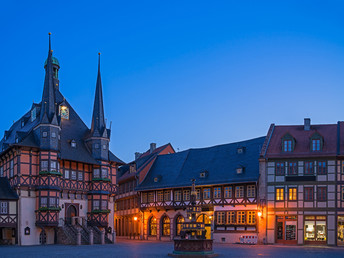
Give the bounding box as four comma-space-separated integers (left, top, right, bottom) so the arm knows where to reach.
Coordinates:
261, 119, 344, 245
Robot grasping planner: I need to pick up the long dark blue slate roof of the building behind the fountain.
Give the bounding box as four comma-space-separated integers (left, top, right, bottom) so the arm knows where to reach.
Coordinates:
136, 137, 265, 191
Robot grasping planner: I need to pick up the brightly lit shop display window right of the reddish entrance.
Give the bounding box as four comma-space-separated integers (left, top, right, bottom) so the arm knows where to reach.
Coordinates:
304, 216, 327, 242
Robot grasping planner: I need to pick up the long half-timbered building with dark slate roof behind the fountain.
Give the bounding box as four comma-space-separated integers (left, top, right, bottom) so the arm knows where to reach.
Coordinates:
137, 137, 265, 243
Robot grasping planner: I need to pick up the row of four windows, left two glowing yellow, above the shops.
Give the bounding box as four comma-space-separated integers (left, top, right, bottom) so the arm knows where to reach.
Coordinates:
276, 186, 330, 201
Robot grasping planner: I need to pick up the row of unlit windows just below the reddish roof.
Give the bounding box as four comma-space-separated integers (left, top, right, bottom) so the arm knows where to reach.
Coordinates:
275, 161, 327, 176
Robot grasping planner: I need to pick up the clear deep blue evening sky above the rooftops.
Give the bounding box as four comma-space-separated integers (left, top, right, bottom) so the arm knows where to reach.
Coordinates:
0, 0, 344, 162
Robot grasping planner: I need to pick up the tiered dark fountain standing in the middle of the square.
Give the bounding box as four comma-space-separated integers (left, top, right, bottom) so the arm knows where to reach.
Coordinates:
169, 179, 217, 257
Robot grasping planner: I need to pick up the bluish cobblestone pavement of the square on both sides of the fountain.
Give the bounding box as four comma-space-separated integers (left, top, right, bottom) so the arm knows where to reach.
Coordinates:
0, 240, 344, 258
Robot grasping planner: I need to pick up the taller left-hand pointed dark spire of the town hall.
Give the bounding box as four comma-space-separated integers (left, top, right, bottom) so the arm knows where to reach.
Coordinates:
40, 32, 56, 122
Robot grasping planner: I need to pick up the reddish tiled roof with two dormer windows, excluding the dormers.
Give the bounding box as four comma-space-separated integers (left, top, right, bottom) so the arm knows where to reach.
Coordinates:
263, 124, 338, 158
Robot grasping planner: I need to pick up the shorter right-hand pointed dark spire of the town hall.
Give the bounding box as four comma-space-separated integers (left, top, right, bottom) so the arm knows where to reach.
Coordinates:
91, 53, 106, 136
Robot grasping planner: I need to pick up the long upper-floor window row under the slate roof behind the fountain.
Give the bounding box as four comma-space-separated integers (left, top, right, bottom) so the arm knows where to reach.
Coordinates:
141, 185, 256, 203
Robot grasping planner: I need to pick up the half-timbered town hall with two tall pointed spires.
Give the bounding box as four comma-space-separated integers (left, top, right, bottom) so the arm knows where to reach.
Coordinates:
0, 36, 124, 245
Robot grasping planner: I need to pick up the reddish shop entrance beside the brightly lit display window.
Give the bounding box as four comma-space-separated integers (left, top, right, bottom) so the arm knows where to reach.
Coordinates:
276, 216, 297, 244
